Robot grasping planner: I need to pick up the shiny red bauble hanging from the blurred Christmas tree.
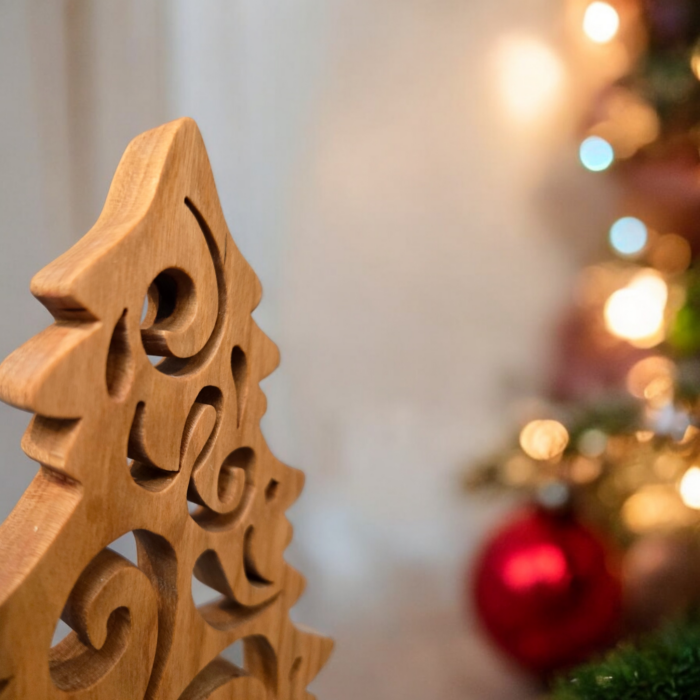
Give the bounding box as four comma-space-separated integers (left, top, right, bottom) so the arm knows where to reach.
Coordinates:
470, 509, 622, 674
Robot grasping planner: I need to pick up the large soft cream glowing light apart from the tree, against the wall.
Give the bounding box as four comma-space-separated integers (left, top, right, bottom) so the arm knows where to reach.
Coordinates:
496, 35, 564, 124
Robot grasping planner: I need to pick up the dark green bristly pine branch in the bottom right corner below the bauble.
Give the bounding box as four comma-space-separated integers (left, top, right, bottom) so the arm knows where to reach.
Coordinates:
552, 619, 700, 700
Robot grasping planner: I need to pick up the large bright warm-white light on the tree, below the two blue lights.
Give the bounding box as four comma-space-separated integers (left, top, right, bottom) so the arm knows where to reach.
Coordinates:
605, 270, 668, 346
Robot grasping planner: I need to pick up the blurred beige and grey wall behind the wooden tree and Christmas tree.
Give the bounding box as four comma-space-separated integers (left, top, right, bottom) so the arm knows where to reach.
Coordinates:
0, 0, 700, 700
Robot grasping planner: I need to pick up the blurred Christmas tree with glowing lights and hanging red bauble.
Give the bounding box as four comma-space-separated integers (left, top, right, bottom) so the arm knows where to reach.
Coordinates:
465, 0, 700, 698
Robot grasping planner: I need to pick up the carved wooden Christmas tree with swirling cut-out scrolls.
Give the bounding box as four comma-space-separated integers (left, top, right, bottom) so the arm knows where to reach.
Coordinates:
0, 119, 332, 700
